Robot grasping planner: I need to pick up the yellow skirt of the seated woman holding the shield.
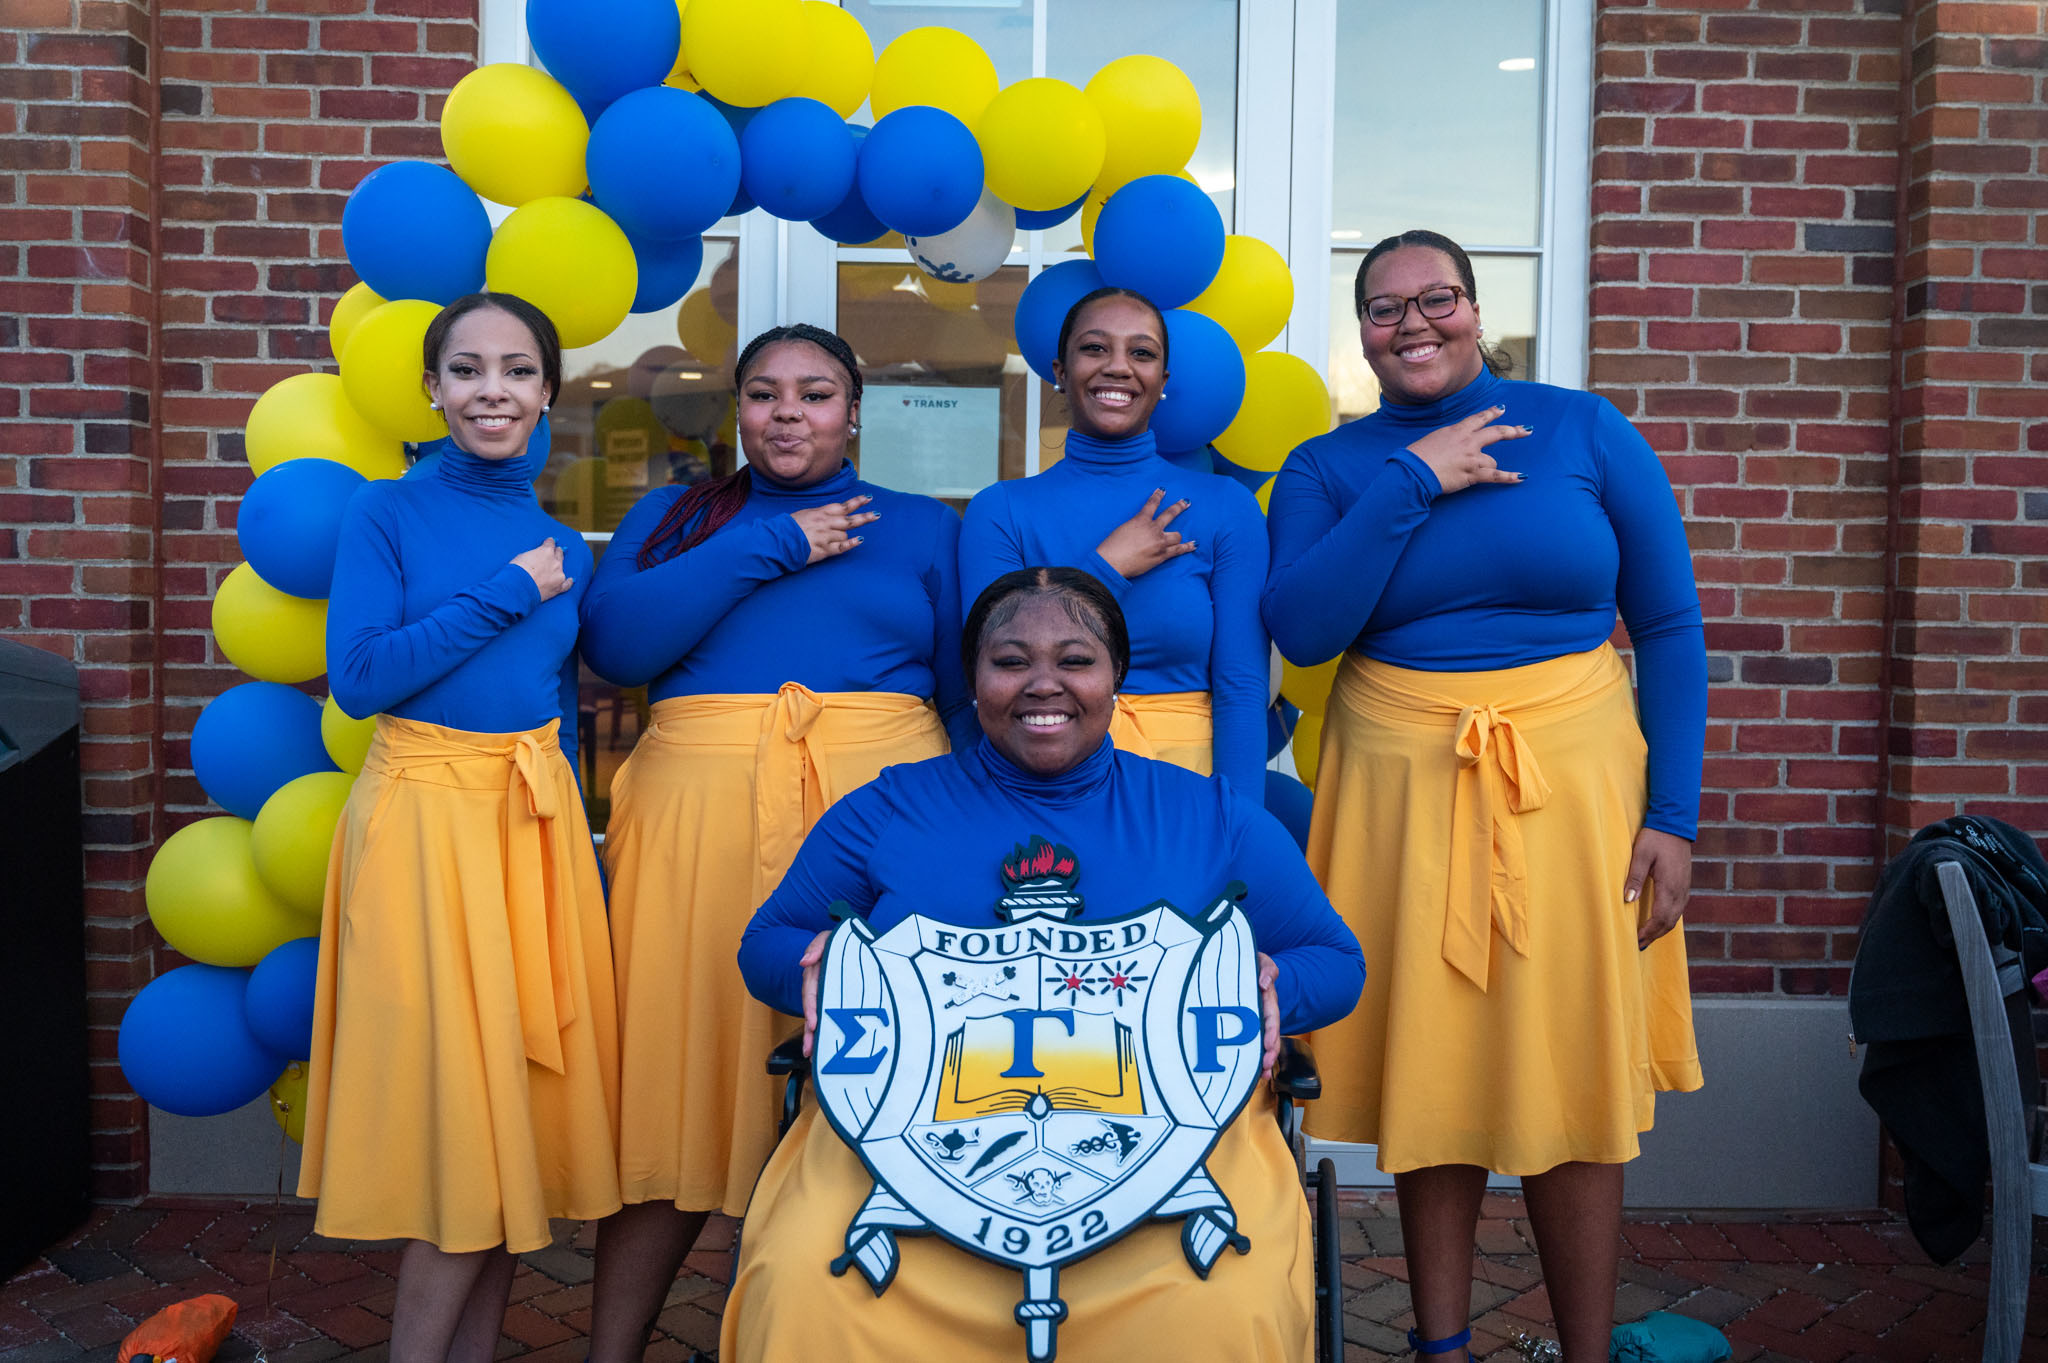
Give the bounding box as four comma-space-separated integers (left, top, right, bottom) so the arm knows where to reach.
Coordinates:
719, 1087, 1315, 1363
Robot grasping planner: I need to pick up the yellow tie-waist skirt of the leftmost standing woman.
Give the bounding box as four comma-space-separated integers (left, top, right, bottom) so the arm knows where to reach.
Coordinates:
299, 714, 618, 1252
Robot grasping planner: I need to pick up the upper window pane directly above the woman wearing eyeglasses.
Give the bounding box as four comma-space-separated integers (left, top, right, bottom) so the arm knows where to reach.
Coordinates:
1327, 0, 1544, 246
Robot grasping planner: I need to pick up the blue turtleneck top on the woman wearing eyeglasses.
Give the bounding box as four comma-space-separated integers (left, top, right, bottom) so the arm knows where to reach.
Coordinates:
1264, 370, 1706, 837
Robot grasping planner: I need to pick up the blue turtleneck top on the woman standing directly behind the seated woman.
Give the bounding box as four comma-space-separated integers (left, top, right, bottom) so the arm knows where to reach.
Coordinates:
961, 430, 1272, 785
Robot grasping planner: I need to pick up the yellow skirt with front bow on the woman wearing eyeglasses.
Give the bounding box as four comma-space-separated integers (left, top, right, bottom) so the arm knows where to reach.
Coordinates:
1307, 645, 1700, 1175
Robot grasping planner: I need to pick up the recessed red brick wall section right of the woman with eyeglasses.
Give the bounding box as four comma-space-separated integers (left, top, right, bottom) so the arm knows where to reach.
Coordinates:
1591, 0, 1901, 995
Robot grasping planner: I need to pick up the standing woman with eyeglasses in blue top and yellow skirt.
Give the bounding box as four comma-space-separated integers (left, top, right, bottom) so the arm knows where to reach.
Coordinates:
1262, 231, 1706, 1363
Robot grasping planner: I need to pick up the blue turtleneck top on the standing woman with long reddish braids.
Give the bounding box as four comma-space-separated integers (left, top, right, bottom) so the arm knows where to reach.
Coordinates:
584, 465, 981, 747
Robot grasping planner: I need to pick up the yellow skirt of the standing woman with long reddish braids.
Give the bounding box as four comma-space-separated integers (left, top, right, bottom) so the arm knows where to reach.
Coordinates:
604, 682, 946, 1216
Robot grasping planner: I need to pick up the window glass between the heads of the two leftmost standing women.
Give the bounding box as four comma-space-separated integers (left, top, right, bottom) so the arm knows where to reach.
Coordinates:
537, 237, 739, 532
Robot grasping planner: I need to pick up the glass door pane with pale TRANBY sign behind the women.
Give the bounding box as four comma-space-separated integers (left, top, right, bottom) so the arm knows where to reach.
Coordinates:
840, 262, 1036, 510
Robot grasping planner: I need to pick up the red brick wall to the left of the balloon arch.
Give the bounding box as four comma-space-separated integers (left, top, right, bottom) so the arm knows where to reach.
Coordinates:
0, 0, 477, 1197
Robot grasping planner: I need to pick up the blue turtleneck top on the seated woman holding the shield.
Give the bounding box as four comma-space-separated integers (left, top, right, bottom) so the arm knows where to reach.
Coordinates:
739, 739, 1366, 1031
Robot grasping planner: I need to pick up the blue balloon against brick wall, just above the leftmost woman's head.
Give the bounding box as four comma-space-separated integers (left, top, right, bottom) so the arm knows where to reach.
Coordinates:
342, 162, 492, 303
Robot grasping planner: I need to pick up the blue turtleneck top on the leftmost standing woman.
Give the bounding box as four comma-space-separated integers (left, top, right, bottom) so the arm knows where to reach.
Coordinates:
328, 444, 592, 767
